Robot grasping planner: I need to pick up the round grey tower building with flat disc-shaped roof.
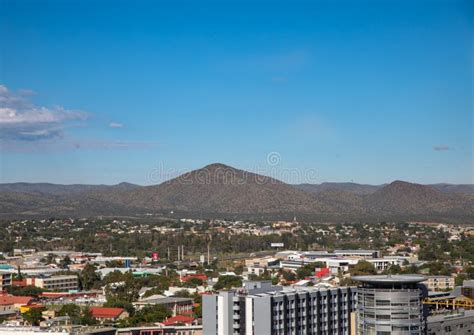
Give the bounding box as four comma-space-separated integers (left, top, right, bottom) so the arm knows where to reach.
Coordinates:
353, 275, 427, 335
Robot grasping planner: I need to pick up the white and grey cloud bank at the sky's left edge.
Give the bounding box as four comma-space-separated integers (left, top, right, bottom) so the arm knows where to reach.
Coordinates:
0, 84, 160, 152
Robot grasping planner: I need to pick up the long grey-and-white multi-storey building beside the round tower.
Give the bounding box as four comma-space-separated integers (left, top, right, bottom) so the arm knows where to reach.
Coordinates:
203, 284, 356, 335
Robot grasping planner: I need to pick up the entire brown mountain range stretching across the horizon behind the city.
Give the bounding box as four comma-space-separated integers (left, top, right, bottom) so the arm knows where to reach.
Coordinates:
0, 164, 474, 223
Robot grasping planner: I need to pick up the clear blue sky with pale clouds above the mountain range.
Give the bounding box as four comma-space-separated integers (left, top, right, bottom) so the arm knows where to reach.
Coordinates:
0, 0, 474, 184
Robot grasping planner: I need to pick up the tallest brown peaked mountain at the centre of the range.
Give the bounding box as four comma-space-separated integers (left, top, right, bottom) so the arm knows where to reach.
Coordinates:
96, 164, 327, 214
